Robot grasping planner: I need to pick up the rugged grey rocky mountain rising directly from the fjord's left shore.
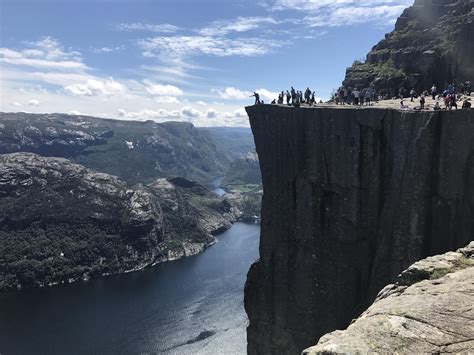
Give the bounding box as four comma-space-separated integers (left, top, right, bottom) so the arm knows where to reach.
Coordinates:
0, 153, 235, 290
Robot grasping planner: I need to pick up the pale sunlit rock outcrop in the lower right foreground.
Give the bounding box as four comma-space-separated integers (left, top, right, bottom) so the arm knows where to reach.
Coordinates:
303, 242, 474, 355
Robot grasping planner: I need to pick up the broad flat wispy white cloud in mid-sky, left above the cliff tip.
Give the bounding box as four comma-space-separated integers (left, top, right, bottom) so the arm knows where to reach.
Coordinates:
138, 36, 287, 58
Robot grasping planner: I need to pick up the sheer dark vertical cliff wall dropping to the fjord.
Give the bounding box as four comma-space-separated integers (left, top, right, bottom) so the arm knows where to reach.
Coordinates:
245, 105, 474, 354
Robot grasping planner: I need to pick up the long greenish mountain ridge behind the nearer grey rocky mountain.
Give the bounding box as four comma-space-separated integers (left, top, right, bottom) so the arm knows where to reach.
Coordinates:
0, 113, 230, 183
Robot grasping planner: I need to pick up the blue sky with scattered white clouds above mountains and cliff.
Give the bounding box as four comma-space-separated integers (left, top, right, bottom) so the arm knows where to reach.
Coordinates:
0, 0, 412, 126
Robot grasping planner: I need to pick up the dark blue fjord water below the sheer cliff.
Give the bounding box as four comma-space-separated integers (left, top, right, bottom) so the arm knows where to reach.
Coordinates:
0, 223, 260, 355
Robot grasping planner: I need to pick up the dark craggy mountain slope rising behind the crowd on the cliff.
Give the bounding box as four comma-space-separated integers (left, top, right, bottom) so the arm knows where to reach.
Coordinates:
343, 0, 474, 97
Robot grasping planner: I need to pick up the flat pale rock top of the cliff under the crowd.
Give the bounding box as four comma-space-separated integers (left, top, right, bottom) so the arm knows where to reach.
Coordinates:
249, 97, 472, 112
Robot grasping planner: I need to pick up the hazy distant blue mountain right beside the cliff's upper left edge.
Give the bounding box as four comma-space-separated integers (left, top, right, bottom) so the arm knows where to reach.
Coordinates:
198, 127, 255, 162
